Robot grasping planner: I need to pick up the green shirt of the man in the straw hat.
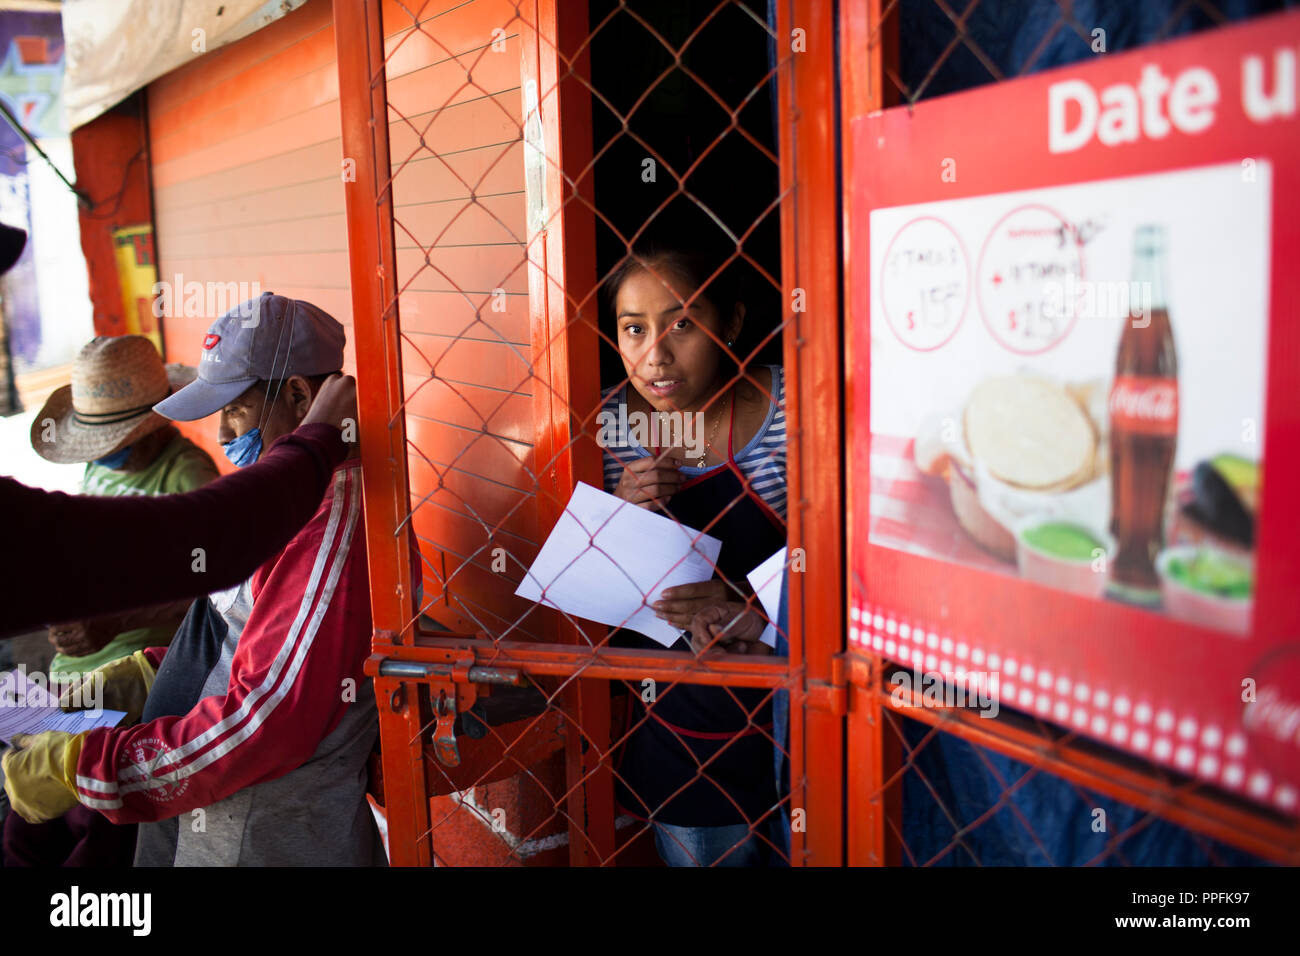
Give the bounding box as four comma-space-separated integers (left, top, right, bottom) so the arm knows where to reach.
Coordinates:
49, 434, 217, 675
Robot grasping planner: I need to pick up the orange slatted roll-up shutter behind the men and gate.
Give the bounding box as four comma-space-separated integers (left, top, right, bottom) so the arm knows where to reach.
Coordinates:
148, 0, 537, 631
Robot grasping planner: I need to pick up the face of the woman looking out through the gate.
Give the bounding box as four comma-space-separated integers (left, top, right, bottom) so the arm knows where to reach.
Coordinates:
614, 268, 745, 411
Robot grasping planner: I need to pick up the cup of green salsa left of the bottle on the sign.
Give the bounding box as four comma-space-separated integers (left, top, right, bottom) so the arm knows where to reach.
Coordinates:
1015, 515, 1114, 598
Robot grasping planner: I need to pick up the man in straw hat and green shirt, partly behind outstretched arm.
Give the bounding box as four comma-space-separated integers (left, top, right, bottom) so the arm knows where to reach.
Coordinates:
31, 336, 217, 678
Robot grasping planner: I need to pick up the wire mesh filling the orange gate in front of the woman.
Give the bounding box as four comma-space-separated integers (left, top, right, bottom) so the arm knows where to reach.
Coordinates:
366, 1, 789, 865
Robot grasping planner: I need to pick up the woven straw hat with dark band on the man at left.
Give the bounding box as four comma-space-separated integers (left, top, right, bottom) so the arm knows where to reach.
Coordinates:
31, 336, 195, 464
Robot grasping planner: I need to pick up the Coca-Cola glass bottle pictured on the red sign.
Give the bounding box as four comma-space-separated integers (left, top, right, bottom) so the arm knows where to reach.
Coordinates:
1108, 225, 1178, 606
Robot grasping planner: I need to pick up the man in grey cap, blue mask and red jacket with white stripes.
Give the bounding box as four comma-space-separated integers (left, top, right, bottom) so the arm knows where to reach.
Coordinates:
1, 293, 420, 866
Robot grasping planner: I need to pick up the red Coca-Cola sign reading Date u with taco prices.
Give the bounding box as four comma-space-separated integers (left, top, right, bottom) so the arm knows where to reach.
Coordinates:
846, 7, 1300, 814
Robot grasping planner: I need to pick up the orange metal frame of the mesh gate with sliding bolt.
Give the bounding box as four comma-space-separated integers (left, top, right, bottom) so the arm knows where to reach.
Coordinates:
334, 0, 846, 865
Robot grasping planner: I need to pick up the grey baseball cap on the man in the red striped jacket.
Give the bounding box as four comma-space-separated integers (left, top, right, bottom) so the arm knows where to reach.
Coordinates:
153, 293, 346, 421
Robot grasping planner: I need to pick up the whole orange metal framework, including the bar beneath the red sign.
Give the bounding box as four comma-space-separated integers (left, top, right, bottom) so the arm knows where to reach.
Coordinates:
334, 0, 1300, 865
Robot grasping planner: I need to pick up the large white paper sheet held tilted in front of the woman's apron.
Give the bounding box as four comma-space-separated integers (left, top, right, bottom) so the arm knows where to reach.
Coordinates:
515, 483, 723, 648
